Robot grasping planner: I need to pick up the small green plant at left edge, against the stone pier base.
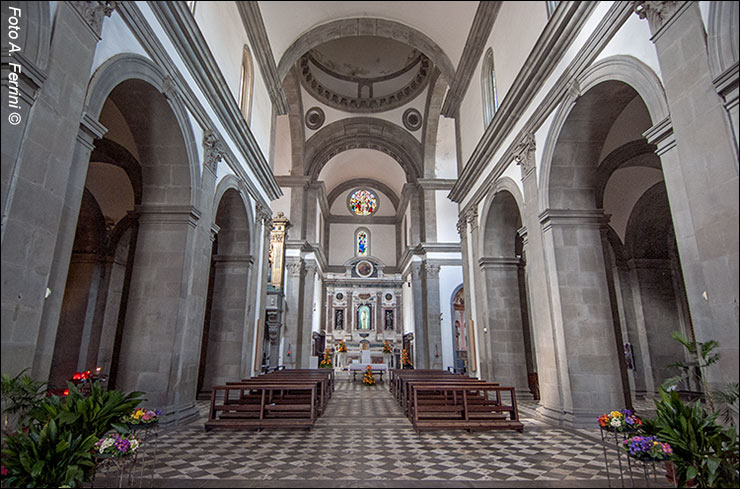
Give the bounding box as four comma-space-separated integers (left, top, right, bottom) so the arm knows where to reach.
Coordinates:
0, 369, 47, 432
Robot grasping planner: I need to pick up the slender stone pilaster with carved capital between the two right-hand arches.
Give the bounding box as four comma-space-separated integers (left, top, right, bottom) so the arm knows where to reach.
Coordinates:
516, 133, 568, 421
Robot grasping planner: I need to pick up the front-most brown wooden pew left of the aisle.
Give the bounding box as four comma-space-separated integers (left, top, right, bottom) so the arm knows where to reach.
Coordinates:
205, 381, 318, 431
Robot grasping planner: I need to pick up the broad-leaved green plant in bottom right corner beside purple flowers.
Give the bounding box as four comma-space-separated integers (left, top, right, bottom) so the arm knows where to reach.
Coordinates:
643, 388, 738, 487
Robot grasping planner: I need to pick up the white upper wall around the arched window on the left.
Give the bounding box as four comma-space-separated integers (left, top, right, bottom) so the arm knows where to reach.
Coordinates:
195, 2, 272, 155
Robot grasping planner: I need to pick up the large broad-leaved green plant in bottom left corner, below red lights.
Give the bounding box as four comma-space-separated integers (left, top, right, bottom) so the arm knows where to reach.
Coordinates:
2, 419, 97, 487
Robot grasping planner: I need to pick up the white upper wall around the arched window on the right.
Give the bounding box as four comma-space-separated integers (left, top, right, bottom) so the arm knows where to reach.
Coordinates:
460, 1, 547, 165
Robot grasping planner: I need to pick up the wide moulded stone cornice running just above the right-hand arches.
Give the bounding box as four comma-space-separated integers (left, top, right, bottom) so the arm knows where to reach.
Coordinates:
449, 2, 632, 209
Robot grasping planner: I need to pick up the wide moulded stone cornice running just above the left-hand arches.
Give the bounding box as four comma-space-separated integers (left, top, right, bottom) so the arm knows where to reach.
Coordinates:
143, 1, 282, 200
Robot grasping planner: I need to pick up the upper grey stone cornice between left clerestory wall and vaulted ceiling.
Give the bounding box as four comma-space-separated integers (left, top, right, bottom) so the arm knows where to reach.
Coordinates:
236, 2, 288, 115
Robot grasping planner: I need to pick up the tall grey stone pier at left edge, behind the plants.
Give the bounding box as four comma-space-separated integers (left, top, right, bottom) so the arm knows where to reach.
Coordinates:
1, 2, 112, 380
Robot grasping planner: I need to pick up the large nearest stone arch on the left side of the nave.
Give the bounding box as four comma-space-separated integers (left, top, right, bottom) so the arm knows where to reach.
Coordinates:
84, 53, 200, 205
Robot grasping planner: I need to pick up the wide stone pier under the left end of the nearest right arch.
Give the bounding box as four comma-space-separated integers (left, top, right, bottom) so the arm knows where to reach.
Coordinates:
541, 209, 625, 424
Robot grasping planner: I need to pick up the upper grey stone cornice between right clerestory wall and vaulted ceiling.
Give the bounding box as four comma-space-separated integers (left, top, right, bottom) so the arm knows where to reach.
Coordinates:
442, 1, 503, 117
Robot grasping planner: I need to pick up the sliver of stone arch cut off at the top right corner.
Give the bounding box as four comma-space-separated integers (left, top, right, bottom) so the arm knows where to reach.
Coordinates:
707, 2, 740, 77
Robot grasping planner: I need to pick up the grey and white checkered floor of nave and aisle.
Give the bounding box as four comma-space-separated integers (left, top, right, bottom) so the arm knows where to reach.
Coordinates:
101, 373, 663, 487
